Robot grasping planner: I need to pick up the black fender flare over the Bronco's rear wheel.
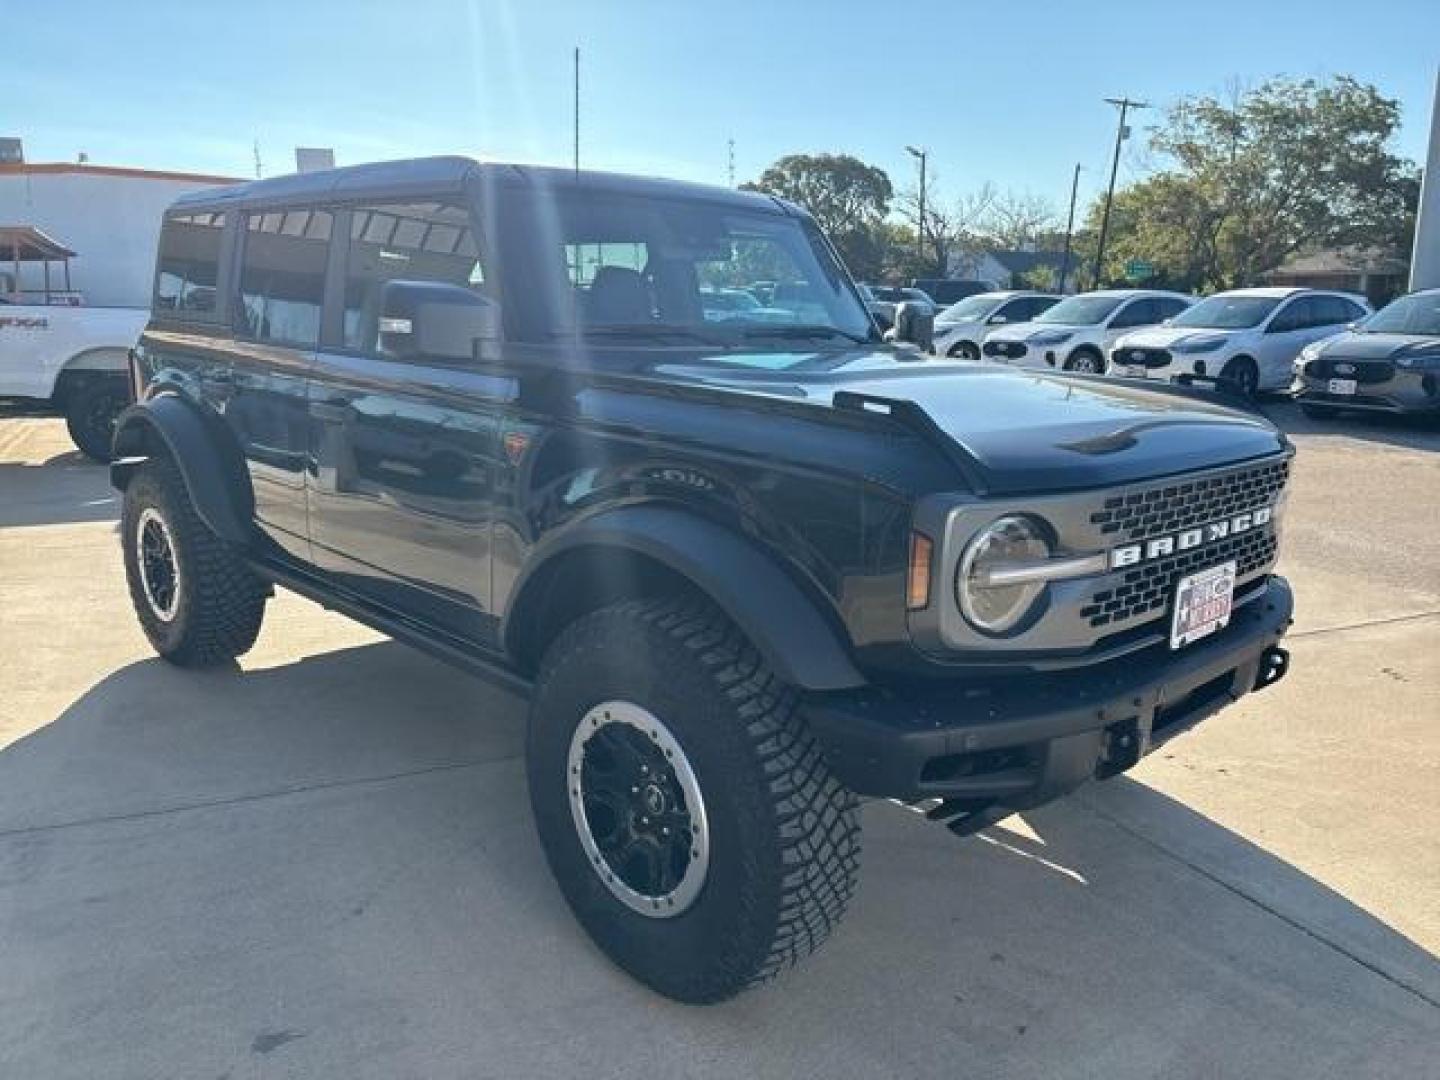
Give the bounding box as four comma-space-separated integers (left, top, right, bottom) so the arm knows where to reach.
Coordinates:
109, 395, 255, 544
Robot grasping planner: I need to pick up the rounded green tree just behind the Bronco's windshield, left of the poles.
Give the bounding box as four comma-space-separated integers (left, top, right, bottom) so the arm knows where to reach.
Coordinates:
742, 154, 894, 278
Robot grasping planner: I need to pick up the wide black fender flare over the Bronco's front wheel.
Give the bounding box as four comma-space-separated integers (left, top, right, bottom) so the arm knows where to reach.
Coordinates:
501, 507, 867, 691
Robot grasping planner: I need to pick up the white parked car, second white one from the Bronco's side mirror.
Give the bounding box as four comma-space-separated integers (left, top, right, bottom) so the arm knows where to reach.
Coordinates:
981, 289, 1195, 372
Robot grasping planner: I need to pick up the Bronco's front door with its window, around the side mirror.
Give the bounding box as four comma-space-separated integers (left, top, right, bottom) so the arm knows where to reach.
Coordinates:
308, 200, 514, 644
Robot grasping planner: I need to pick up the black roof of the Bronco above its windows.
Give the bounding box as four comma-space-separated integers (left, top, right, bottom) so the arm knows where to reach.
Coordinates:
171, 157, 788, 213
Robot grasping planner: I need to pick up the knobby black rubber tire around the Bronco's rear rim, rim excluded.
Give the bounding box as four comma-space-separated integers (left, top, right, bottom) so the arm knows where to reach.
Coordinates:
121, 458, 269, 668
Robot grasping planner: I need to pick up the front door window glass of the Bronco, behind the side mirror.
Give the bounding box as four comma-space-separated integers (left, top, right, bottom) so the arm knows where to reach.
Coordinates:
344, 202, 485, 353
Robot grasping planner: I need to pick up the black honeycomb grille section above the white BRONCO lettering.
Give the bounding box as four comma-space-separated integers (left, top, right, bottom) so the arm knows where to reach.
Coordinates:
1090, 457, 1290, 544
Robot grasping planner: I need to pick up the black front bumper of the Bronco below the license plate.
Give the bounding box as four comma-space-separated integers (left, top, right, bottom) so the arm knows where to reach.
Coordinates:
805, 577, 1295, 816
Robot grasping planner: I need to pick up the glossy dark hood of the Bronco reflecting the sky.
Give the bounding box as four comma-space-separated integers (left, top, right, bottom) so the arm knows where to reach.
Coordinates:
652, 347, 1289, 494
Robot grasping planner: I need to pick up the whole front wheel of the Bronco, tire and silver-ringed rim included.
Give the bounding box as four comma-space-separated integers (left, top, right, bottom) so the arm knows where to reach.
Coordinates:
527, 598, 860, 1004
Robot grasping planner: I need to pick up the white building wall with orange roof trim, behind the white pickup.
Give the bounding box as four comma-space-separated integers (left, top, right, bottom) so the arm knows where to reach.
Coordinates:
0, 166, 233, 307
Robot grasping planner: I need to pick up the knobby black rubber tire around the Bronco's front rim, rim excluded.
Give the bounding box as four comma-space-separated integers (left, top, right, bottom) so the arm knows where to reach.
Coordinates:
527, 598, 860, 1004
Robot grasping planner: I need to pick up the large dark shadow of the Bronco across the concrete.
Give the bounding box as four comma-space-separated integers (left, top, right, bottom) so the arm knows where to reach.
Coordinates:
0, 642, 1440, 1077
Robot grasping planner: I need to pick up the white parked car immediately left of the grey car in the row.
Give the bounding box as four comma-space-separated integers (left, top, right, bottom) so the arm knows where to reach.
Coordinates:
1109, 288, 1371, 395
